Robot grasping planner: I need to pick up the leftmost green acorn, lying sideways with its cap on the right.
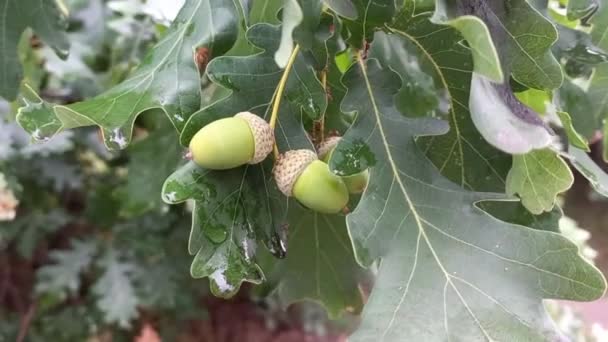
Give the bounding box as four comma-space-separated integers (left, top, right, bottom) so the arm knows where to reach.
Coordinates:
190, 112, 274, 170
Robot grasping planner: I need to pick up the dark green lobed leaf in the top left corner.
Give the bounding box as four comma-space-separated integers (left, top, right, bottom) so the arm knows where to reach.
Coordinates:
0, 0, 70, 100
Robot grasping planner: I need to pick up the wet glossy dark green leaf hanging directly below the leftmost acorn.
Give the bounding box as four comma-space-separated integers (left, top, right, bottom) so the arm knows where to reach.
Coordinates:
163, 162, 268, 297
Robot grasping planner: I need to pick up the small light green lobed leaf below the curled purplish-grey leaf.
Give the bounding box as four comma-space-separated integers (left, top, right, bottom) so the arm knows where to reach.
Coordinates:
507, 149, 574, 215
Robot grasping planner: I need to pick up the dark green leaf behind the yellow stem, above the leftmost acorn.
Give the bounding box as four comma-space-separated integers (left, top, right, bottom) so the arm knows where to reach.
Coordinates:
180, 24, 327, 143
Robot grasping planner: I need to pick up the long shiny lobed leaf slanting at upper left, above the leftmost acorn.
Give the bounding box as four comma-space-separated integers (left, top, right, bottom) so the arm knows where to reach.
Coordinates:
17, 0, 241, 149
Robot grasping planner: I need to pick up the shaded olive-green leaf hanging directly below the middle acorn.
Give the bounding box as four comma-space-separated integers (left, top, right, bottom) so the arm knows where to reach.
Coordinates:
263, 201, 363, 318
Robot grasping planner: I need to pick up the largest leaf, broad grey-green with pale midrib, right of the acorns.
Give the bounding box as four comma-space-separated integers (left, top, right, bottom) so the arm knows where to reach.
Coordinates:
330, 44, 605, 341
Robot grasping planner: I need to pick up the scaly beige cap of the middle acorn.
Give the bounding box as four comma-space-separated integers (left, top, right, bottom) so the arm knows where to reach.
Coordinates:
273, 150, 319, 196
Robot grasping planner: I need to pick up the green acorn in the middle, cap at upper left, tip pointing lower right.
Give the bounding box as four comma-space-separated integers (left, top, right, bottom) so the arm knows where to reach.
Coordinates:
273, 150, 348, 214
